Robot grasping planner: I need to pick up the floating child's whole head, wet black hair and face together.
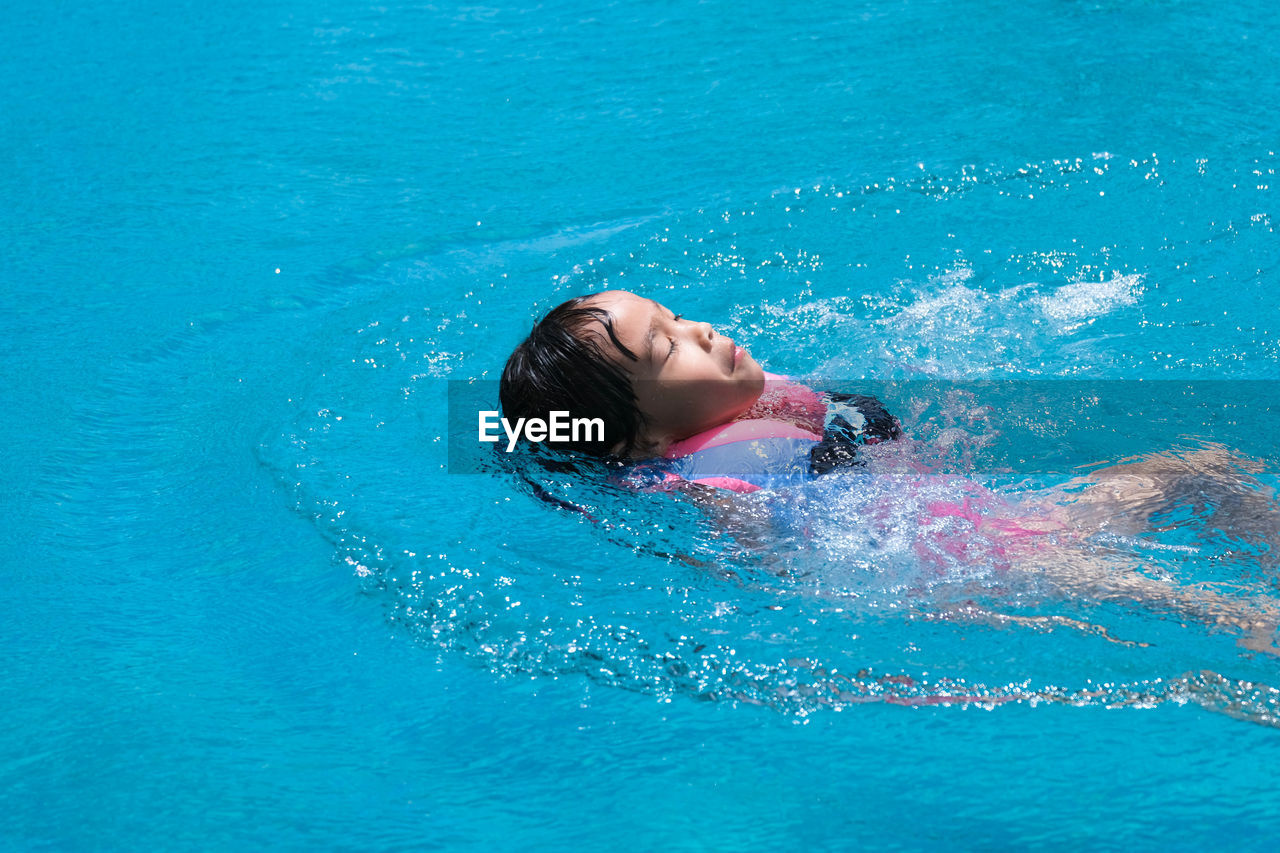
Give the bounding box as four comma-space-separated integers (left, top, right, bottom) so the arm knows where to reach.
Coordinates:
499, 291, 764, 457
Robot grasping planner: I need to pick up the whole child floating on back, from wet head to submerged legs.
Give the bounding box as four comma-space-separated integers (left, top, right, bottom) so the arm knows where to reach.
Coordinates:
499, 291, 1280, 653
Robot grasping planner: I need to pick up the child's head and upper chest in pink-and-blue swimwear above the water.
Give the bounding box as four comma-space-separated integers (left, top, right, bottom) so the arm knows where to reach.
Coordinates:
499, 291, 900, 481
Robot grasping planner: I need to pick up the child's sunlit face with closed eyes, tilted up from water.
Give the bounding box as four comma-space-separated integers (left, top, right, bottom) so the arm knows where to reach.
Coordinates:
589, 291, 764, 453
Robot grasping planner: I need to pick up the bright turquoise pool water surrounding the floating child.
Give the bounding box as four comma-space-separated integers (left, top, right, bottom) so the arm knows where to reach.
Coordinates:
0, 0, 1280, 849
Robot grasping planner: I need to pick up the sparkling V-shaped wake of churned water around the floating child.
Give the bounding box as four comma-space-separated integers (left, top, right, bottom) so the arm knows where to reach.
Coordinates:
260, 156, 1276, 724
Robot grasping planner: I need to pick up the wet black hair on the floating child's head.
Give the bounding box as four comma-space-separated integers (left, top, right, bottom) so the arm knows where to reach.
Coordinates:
498, 296, 645, 456
